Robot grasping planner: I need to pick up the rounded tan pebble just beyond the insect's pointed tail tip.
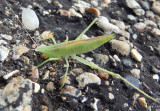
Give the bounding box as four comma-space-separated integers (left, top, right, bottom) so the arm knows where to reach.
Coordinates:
110, 39, 130, 56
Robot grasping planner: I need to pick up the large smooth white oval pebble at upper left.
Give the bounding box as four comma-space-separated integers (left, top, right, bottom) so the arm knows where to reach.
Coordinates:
22, 8, 39, 31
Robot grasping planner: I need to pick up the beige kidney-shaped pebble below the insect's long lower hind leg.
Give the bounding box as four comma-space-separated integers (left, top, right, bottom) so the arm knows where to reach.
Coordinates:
76, 72, 101, 89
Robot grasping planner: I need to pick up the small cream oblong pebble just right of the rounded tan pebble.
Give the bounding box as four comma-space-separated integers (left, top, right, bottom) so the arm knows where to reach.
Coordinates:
131, 49, 142, 62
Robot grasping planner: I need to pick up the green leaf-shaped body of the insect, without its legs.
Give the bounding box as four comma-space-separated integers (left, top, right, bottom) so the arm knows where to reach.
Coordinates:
36, 34, 114, 58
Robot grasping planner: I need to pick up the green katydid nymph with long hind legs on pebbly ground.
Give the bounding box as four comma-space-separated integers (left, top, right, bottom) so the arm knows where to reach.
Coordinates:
36, 18, 158, 102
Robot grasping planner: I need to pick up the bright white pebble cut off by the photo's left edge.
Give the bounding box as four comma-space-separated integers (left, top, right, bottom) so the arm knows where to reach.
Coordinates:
0, 46, 9, 61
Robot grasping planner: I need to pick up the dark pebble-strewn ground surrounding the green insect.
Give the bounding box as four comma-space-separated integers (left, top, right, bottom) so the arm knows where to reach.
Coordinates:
0, 0, 160, 111
